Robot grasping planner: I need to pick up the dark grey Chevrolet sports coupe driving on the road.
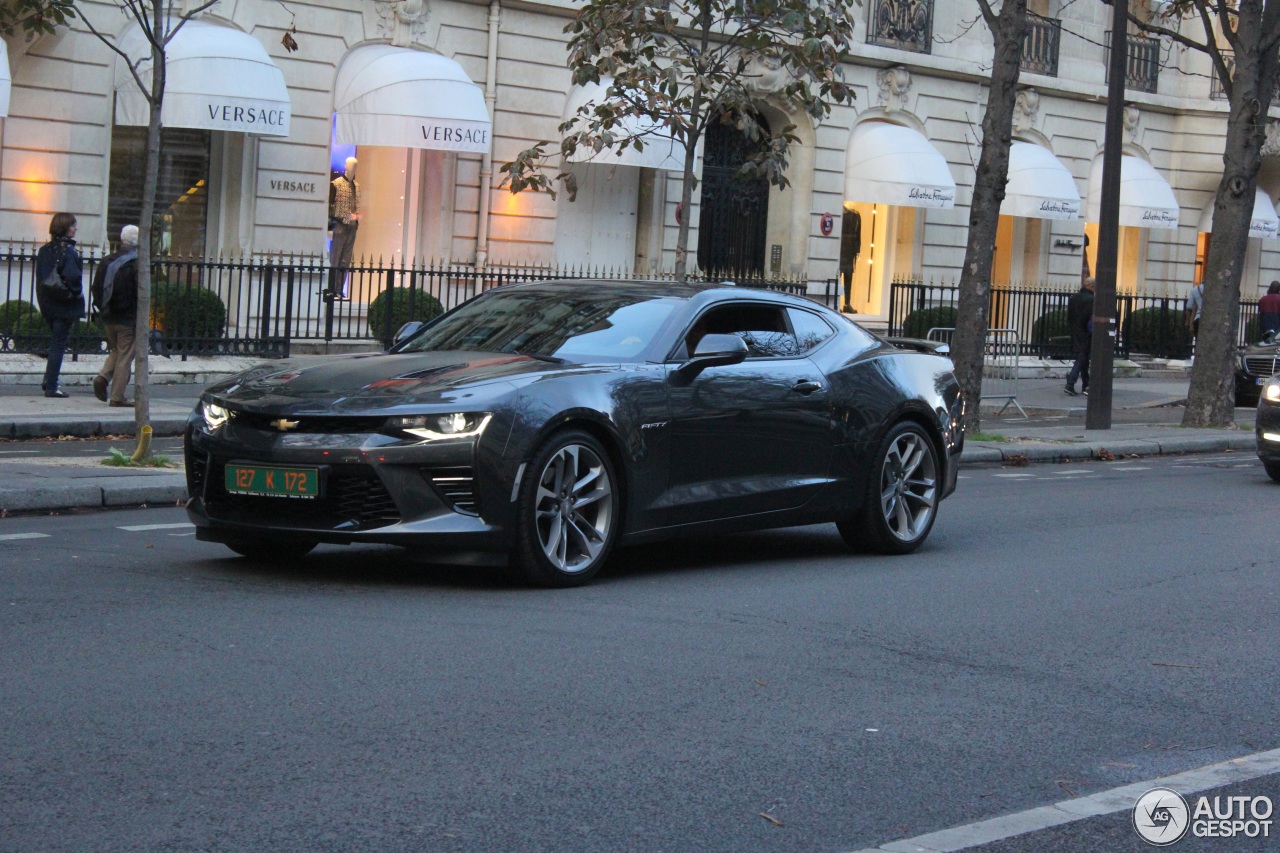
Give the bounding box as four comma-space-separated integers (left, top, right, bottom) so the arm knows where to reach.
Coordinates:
186, 280, 964, 587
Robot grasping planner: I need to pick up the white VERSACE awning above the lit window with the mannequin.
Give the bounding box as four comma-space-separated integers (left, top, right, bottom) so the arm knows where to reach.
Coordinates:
333, 45, 493, 154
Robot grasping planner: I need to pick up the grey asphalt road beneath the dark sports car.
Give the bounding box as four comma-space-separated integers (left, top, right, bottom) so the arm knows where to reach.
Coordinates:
0, 453, 1280, 852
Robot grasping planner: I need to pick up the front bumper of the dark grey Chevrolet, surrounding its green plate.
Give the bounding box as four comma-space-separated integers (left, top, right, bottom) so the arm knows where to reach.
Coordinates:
183, 420, 511, 552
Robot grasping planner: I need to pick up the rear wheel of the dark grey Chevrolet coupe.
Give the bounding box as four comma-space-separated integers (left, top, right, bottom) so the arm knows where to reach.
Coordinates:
836, 420, 942, 555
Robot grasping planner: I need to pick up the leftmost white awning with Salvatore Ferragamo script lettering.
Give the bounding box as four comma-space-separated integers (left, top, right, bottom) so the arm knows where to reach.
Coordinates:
845, 122, 956, 207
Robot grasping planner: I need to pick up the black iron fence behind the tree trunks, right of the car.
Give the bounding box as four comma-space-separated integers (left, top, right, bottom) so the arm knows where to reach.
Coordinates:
888, 279, 1260, 359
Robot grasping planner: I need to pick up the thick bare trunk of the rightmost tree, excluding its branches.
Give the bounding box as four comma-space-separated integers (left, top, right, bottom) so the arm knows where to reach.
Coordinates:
1183, 0, 1280, 427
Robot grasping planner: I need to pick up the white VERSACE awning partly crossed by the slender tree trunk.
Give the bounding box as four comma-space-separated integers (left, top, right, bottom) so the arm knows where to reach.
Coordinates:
115, 20, 292, 136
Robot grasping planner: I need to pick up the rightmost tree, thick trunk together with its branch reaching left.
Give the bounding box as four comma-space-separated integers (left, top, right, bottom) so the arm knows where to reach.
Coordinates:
1130, 0, 1280, 427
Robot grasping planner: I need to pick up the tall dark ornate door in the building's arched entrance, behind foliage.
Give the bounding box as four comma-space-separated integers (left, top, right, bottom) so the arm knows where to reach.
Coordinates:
698, 118, 769, 277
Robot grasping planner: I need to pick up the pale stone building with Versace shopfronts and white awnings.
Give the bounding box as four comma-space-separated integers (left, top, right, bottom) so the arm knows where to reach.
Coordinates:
0, 0, 1280, 318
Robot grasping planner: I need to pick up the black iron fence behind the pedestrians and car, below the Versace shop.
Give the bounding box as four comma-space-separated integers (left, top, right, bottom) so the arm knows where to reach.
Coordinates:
0, 245, 833, 356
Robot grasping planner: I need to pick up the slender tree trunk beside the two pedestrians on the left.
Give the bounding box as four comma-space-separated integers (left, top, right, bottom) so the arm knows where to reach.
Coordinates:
133, 6, 165, 439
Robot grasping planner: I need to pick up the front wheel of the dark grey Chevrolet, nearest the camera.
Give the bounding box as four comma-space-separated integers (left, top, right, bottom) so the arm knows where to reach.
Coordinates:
512, 429, 622, 587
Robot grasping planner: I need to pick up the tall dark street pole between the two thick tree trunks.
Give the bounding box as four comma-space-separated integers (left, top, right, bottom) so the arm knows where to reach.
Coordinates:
1084, 0, 1129, 429
